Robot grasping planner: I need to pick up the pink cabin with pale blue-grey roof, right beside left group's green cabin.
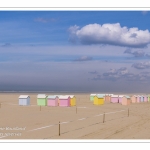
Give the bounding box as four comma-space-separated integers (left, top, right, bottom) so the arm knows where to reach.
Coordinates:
47, 95, 59, 106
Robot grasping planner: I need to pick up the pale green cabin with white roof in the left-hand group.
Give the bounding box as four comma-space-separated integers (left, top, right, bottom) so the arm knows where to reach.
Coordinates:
37, 94, 47, 106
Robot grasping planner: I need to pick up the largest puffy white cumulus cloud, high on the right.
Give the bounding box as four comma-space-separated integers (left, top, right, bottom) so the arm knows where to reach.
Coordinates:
69, 23, 150, 48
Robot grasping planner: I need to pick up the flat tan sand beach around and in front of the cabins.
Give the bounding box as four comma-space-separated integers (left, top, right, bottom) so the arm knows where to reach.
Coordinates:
0, 93, 150, 140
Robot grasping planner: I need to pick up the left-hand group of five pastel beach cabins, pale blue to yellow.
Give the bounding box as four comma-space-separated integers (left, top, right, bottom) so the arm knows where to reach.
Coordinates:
19, 94, 76, 107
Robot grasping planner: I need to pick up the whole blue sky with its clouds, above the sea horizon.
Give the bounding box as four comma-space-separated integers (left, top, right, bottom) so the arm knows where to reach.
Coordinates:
0, 10, 150, 93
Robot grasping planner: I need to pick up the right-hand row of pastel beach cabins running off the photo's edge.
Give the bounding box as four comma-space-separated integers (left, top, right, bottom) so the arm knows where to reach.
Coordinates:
90, 94, 150, 105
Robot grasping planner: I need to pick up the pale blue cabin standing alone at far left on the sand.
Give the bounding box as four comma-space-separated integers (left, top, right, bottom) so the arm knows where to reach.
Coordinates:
19, 95, 30, 106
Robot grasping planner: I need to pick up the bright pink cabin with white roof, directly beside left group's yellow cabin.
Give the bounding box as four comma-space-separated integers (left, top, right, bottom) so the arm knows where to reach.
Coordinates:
59, 96, 71, 107
